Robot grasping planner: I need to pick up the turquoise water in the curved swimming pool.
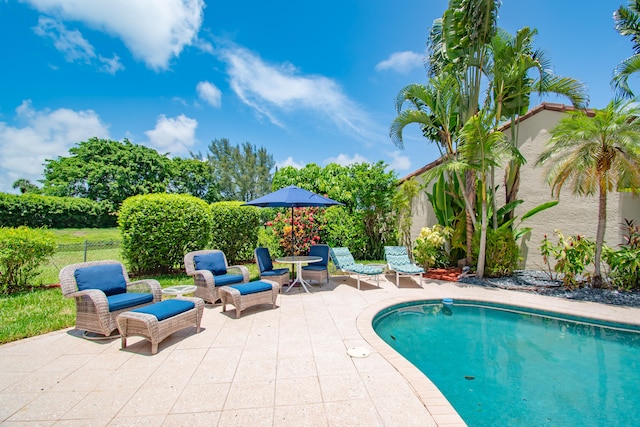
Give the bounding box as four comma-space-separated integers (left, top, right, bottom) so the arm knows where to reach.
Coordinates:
373, 301, 640, 426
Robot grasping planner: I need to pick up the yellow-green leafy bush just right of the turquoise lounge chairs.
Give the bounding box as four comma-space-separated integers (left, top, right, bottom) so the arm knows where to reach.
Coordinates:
413, 224, 453, 271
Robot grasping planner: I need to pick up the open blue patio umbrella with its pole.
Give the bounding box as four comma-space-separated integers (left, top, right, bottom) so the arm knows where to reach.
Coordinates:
244, 185, 344, 255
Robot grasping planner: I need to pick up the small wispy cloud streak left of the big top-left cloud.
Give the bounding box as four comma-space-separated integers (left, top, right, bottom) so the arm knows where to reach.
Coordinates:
33, 16, 124, 74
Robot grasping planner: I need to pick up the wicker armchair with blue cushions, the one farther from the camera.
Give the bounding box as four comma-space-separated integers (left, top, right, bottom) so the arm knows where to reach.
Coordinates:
184, 249, 249, 304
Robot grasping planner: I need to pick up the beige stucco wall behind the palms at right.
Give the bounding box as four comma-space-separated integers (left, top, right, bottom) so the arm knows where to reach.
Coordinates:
412, 104, 640, 269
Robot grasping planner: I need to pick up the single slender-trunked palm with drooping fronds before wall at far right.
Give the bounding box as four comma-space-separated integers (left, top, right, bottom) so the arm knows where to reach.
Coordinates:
537, 100, 640, 287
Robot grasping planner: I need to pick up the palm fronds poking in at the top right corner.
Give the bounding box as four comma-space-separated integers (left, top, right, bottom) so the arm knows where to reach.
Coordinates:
611, 0, 640, 98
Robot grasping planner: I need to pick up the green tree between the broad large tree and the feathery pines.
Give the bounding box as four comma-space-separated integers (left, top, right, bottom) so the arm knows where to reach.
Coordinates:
167, 156, 221, 203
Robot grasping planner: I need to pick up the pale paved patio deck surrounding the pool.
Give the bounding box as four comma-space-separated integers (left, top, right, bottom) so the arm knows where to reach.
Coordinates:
0, 275, 640, 427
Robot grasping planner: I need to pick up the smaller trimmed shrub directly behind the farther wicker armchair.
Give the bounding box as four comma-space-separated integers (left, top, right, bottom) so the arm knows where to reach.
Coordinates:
210, 202, 262, 264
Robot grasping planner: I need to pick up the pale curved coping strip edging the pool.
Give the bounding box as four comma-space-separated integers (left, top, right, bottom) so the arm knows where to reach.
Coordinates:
356, 284, 640, 427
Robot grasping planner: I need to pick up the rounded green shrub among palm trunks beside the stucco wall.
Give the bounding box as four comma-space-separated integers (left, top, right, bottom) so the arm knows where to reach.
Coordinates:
473, 228, 520, 277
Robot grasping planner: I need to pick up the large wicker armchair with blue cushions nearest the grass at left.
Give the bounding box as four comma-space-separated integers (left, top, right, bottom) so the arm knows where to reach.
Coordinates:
60, 260, 162, 338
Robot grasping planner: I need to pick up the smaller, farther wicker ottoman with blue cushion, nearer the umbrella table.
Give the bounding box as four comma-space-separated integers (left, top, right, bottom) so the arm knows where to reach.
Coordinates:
218, 279, 280, 319
